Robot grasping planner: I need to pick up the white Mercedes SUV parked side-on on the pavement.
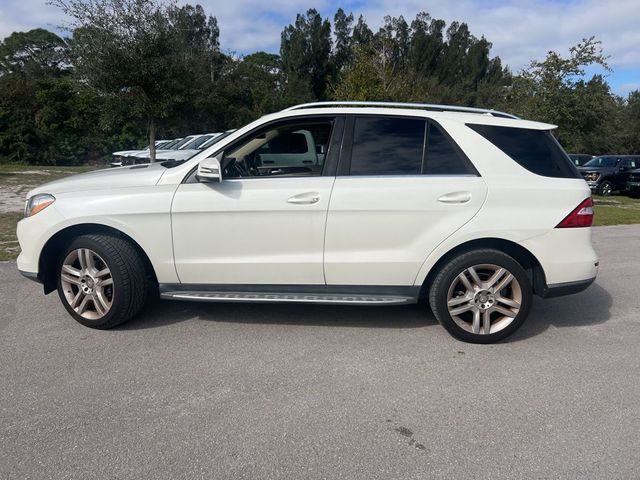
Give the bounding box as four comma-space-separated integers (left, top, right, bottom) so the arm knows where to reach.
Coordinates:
18, 102, 598, 343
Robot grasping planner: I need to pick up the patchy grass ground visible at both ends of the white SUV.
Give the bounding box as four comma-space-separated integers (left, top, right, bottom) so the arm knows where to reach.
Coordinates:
0, 164, 640, 261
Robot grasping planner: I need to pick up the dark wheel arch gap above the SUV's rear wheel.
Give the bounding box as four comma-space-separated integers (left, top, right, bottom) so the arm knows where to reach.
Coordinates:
420, 237, 546, 300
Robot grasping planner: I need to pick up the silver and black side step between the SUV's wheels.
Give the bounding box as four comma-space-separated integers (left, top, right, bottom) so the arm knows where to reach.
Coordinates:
160, 291, 416, 305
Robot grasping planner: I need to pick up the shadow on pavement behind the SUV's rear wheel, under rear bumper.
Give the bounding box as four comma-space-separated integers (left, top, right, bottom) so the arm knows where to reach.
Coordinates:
505, 283, 613, 342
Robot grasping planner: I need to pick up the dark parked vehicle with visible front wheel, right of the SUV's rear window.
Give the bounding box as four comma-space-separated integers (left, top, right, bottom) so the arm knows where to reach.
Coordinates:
578, 155, 640, 197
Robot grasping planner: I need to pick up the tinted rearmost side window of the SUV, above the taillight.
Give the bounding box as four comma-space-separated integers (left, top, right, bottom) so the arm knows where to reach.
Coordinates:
467, 124, 581, 178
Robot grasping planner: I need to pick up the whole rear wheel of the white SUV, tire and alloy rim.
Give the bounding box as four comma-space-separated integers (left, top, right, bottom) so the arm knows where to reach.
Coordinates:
429, 249, 532, 343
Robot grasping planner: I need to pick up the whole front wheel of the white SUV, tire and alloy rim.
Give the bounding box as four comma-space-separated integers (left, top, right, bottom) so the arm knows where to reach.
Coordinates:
57, 235, 148, 329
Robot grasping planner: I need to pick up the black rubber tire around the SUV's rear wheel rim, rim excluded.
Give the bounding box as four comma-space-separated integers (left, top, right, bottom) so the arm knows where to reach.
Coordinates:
429, 249, 533, 343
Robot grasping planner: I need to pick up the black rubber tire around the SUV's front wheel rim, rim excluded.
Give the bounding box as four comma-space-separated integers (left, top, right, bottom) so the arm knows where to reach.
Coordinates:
56, 234, 148, 330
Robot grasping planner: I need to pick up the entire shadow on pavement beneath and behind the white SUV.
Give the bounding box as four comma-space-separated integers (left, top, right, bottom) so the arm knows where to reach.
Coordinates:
118, 284, 613, 342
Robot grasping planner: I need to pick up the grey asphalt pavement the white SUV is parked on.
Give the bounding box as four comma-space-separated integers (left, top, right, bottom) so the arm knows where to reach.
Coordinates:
0, 226, 640, 479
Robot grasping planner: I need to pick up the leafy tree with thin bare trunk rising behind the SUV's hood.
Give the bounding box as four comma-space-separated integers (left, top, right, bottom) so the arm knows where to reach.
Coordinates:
52, 0, 217, 161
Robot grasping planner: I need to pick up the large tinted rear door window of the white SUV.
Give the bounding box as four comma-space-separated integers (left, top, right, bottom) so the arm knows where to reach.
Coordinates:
351, 117, 426, 175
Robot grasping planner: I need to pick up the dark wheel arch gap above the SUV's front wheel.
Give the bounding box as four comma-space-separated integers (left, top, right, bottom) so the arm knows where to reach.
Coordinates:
38, 223, 158, 294
